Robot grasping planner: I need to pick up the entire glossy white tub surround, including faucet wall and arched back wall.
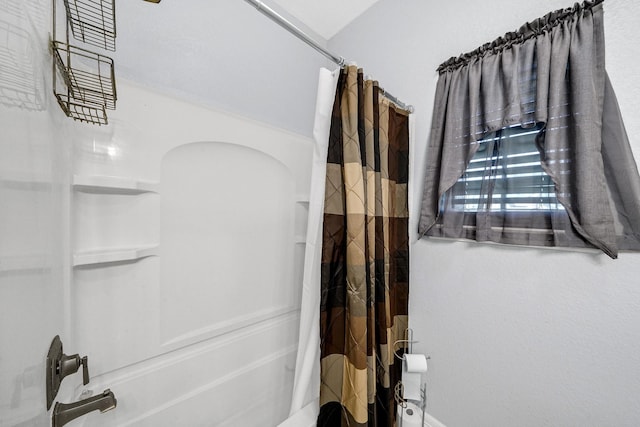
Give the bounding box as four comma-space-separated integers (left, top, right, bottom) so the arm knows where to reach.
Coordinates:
0, 27, 311, 427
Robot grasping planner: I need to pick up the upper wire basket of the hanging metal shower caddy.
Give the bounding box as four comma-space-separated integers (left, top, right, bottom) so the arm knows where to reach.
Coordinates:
64, 0, 116, 51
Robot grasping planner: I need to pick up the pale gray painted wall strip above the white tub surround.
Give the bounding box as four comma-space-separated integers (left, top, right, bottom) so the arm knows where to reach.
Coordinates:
113, 0, 326, 135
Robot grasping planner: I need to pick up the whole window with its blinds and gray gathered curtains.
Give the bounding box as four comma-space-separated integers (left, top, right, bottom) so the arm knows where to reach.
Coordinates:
418, 0, 640, 258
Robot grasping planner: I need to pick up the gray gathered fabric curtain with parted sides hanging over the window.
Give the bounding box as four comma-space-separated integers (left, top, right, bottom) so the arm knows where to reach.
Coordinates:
418, 0, 640, 258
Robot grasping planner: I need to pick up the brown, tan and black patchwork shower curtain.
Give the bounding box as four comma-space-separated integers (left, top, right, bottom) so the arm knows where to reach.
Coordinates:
318, 66, 409, 427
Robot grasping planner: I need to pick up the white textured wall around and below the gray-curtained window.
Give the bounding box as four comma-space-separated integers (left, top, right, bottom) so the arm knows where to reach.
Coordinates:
329, 0, 640, 427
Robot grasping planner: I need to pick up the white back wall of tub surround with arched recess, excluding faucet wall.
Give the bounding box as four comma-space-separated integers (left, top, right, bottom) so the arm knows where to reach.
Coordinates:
72, 79, 312, 426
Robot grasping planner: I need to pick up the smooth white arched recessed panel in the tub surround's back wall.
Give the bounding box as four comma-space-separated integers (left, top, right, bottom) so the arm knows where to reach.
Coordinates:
159, 142, 297, 348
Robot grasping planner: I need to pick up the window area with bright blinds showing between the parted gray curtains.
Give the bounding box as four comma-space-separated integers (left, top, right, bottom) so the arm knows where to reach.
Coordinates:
428, 124, 585, 247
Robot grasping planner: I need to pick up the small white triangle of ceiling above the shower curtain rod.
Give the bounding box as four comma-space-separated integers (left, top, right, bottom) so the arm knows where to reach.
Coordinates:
273, 0, 379, 40
